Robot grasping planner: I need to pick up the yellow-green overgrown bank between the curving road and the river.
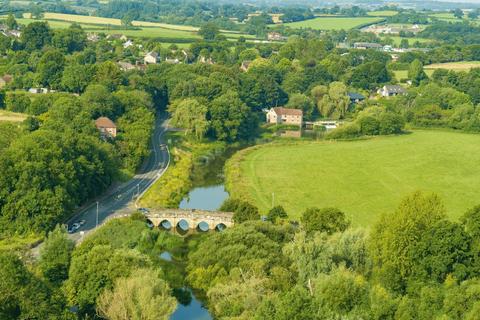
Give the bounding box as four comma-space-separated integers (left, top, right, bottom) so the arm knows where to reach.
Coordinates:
139, 131, 227, 208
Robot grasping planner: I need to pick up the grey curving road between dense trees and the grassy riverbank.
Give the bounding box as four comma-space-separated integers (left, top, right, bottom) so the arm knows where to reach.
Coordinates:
68, 117, 170, 241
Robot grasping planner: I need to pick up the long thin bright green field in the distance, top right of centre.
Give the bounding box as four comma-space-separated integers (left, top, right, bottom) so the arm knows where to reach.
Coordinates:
285, 17, 382, 30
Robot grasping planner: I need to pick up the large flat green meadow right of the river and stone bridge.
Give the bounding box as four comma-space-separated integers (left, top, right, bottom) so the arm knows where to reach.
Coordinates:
227, 131, 480, 226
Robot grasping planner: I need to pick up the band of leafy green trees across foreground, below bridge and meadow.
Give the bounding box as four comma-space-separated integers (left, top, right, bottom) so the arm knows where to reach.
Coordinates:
4, 192, 480, 319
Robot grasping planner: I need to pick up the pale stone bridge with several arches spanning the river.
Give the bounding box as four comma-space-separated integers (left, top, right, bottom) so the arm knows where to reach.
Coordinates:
145, 209, 234, 230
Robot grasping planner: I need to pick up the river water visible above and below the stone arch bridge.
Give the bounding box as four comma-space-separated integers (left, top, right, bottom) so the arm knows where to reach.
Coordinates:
170, 149, 231, 320
